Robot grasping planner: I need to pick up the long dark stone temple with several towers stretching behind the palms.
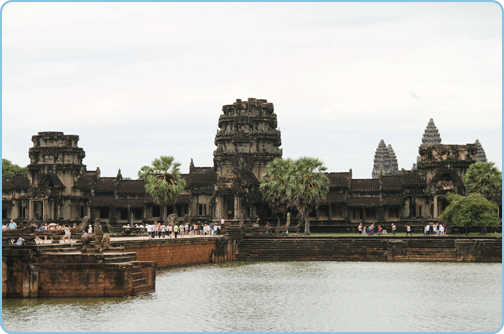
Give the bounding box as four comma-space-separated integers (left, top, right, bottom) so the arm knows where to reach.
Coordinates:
2, 98, 502, 232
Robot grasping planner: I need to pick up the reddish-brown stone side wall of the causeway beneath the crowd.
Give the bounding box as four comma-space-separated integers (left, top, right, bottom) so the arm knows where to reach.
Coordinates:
113, 237, 238, 269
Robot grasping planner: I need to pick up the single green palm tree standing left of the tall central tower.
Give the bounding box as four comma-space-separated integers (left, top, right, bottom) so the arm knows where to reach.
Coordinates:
138, 156, 186, 225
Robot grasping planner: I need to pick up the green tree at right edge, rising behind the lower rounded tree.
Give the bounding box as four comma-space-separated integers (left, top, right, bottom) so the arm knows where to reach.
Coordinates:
464, 161, 502, 201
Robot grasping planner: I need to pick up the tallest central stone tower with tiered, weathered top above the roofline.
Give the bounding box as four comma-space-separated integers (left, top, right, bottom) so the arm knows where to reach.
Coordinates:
214, 98, 282, 180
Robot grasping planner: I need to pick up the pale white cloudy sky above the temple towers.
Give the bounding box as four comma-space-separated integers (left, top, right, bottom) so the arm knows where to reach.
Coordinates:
2, 2, 502, 178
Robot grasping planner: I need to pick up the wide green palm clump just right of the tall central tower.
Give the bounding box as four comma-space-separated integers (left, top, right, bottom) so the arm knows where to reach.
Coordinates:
260, 157, 329, 235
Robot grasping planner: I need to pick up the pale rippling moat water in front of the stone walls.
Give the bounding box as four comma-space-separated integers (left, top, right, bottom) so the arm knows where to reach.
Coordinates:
2, 262, 502, 332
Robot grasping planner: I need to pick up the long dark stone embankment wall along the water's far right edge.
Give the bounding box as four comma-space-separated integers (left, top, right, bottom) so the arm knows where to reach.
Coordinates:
236, 236, 502, 262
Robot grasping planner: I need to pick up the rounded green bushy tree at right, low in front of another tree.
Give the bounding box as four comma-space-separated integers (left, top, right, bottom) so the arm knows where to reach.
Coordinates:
439, 193, 500, 233
